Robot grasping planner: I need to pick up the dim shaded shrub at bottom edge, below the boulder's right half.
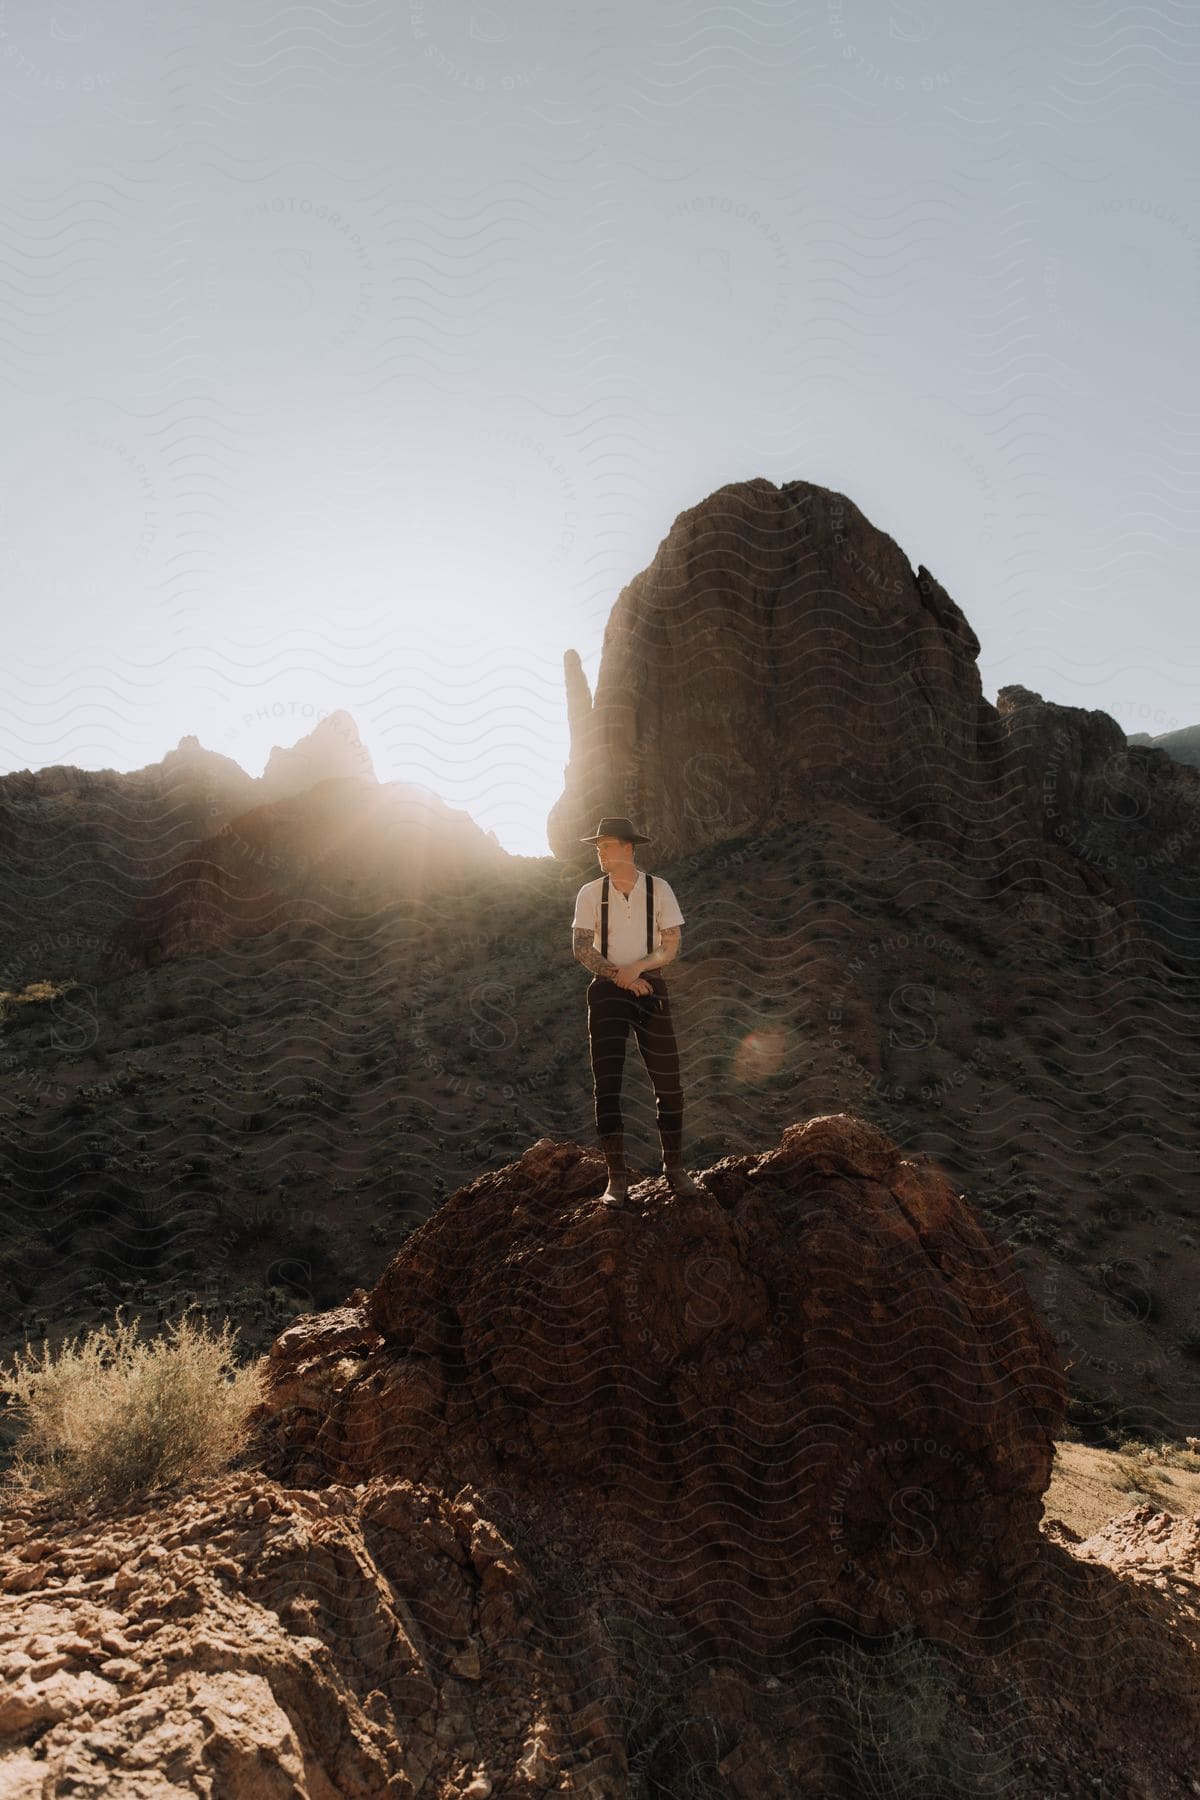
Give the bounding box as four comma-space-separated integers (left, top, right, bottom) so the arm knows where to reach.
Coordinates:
831, 1631, 1011, 1800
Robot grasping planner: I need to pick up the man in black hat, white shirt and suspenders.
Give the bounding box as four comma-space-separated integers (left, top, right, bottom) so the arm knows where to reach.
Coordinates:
570, 819, 703, 1201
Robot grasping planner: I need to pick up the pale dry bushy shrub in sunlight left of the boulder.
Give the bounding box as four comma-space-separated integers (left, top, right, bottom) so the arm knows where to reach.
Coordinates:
0, 1309, 263, 1501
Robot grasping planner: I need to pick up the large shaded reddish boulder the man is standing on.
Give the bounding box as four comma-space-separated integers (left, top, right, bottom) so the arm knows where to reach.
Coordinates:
261, 1114, 1065, 1667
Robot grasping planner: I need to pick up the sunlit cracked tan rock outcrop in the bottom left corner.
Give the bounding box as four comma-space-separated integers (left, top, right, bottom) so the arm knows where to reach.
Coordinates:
0, 1476, 611, 1800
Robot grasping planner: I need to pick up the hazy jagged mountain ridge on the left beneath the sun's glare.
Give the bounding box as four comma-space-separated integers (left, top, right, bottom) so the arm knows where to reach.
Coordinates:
0, 711, 504, 992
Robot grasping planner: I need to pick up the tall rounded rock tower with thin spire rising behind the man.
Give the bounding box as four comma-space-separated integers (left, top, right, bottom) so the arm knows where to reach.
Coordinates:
547, 479, 1180, 956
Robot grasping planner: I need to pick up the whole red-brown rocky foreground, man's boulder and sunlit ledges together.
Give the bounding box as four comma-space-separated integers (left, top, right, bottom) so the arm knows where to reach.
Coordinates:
0, 1116, 1200, 1800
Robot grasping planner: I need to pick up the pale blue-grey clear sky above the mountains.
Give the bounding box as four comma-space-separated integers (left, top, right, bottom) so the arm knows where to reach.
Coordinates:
0, 0, 1200, 855
